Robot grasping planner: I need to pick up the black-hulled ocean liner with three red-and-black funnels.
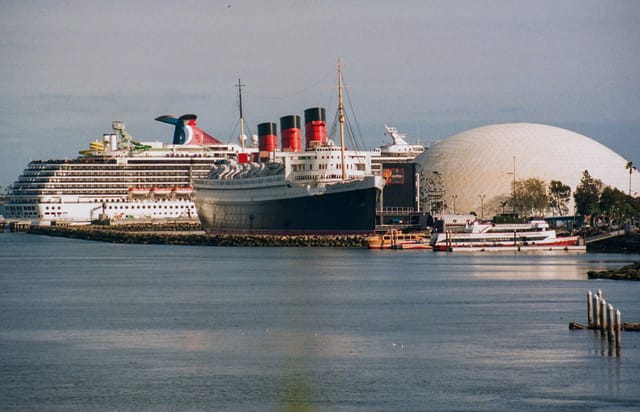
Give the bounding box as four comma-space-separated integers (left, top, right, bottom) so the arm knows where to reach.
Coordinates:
194, 67, 384, 234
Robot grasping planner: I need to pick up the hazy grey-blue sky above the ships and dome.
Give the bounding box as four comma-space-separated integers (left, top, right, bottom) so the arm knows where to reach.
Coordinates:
0, 0, 640, 187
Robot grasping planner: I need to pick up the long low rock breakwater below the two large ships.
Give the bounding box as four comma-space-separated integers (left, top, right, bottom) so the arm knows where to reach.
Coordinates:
29, 223, 365, 248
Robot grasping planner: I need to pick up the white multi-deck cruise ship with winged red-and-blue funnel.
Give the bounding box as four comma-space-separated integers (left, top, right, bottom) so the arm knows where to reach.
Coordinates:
5, 114, 256, 225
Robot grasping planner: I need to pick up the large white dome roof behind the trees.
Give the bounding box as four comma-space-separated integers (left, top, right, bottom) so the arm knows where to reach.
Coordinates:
416, 123, 640, 216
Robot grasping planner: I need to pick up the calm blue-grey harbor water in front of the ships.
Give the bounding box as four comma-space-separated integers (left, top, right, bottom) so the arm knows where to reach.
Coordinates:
0, 233, 640, 411
